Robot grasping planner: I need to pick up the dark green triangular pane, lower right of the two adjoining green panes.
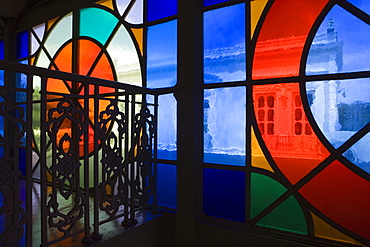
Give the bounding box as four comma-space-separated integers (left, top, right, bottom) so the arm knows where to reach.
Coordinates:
257, 196, 307, 234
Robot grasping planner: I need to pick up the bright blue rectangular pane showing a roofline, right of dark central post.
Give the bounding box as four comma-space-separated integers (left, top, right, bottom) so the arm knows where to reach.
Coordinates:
204, 4, 246, 83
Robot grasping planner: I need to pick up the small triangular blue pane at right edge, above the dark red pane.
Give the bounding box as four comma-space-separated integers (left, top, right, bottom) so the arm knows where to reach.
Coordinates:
343, 133, 370, 173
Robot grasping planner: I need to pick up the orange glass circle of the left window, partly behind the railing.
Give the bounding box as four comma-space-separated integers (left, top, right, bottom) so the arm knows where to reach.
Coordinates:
47, 39, 115, 154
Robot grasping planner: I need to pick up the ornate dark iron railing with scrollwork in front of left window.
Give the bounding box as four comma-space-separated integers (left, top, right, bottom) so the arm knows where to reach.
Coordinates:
0, 61, 158, 246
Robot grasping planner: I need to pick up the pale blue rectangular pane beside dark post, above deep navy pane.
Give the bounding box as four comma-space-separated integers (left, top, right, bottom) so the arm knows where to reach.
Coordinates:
203, 87, 246, 166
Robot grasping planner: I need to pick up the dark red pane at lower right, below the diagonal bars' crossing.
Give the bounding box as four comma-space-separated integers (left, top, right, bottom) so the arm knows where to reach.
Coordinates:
299, 161, 370, 239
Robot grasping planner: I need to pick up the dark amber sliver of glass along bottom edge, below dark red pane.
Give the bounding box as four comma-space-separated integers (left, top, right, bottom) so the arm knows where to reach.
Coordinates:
311, 213, 366, 246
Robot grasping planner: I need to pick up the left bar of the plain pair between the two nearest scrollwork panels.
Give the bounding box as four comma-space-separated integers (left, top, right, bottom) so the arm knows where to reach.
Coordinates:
26, 74, 33, 246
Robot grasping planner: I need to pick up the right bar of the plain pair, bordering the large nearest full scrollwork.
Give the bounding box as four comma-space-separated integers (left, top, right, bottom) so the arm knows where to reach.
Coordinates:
40, 76, 48, 246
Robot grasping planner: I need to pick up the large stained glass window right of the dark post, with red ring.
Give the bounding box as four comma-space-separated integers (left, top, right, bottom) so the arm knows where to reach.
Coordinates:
201, 0, 370, 246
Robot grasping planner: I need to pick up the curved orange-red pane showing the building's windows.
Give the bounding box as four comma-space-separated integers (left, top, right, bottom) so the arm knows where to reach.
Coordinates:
253, 83, 329, 184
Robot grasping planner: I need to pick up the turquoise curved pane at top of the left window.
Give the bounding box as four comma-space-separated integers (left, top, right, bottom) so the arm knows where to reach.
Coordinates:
80, 8, 118, 44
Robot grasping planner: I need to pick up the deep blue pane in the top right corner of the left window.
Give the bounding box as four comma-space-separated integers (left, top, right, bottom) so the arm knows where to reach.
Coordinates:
148, 0, 177, 21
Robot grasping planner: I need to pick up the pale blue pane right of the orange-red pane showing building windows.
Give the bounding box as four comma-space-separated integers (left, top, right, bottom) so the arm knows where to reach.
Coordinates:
306, 78, 370, 148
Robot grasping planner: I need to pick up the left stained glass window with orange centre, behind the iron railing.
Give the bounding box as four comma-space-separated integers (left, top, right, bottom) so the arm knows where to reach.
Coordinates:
16, 0, 177, 209
